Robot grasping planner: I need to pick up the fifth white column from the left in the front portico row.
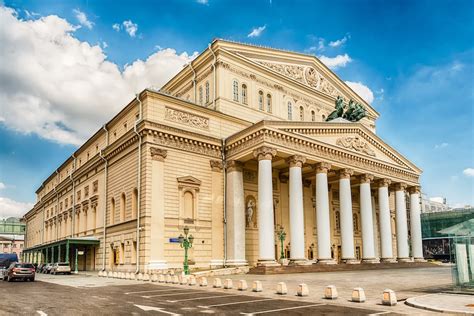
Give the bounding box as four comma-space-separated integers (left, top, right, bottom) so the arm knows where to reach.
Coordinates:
360, 174, 378, 263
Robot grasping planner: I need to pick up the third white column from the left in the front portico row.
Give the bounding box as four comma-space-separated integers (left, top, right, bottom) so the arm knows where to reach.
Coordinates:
316, 162, 336, 264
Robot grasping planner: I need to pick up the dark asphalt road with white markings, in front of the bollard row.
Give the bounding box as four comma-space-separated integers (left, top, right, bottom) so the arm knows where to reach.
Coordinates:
0, 281, 387, 316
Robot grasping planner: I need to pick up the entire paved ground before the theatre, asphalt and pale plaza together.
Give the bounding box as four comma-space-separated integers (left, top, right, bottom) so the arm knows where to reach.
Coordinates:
0, 267, 469, 315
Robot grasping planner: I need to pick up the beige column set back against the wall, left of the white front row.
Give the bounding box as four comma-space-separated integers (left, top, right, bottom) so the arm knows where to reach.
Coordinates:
226, 161, 248, 266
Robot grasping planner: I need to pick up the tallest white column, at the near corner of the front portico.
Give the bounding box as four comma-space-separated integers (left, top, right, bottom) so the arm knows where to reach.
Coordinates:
253, 146, 278, 266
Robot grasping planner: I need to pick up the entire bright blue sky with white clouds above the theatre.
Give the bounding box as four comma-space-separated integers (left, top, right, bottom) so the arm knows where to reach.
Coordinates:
0, 0, 474, 217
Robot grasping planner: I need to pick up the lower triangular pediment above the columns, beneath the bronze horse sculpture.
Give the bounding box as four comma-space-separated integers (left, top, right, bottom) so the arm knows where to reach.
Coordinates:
270, 122, 421, 173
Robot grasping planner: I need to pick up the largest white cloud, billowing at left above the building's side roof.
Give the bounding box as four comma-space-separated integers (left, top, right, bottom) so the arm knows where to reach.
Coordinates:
0, 7, 197, 145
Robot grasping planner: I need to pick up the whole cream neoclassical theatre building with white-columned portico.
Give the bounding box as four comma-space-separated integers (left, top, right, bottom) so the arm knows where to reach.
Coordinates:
24, 40, 423, 272
